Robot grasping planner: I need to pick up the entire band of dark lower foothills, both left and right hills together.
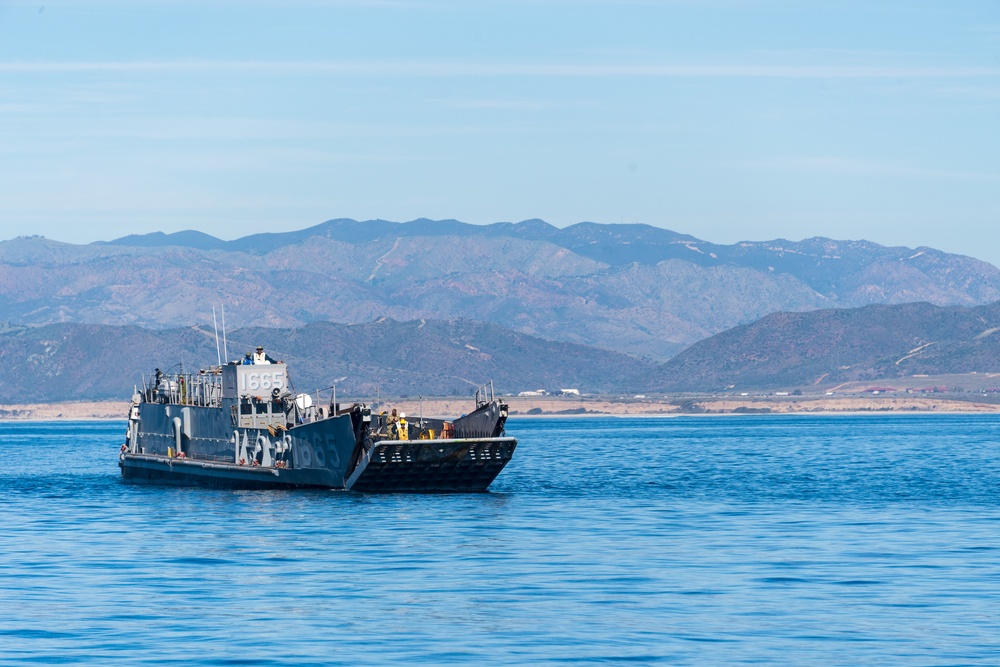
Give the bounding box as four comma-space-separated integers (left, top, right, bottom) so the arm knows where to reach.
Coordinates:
9, 302, 1000, 403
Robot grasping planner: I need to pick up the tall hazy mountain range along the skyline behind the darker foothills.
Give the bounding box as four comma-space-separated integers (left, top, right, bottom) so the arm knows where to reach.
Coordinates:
0, 220, 1000, 360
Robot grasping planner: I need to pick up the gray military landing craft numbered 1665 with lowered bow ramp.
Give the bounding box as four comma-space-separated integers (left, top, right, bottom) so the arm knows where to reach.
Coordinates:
118, 362, 517, 492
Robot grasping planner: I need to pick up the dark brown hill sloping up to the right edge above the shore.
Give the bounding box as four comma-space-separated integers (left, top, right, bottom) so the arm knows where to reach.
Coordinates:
654, 303, 1000, 391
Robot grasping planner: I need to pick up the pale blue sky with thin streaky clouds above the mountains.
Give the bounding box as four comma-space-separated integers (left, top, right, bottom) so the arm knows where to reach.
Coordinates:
0, 0, 1000, 265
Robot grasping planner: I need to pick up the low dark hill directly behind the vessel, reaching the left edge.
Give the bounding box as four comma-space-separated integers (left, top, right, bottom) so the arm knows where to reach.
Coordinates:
0, 319, 654, 403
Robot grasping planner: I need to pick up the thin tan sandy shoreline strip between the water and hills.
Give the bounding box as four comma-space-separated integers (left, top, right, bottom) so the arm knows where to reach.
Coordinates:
0, 395, 1000, 422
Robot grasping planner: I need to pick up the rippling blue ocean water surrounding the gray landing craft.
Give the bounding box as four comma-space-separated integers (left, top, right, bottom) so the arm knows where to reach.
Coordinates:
0, 415, 1000, 665
